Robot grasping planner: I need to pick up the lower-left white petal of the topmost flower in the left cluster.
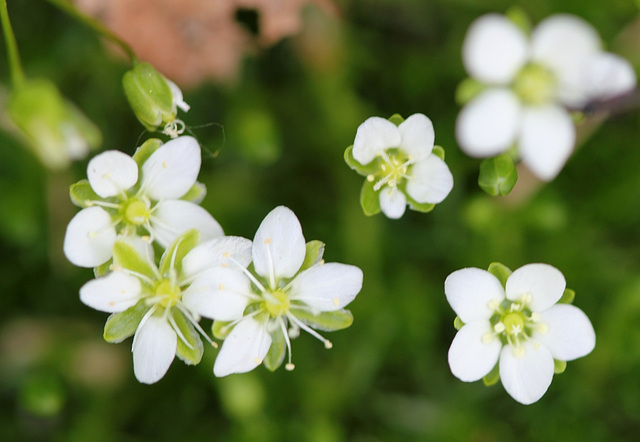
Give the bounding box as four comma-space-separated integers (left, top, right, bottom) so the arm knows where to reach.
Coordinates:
63, 207, 116, 267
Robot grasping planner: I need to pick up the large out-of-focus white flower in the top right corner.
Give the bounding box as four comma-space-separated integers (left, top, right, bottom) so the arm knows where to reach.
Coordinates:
456, 14, 636, 181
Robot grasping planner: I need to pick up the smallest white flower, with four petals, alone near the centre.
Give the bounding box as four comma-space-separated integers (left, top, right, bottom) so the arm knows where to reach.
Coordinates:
352, 114, 453, 219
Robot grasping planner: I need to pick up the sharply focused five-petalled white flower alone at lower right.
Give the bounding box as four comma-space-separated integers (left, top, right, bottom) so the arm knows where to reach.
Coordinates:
444, 264, 595, 404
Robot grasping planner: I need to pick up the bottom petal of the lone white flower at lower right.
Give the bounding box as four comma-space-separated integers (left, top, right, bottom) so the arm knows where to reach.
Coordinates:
500, 342, 553, 405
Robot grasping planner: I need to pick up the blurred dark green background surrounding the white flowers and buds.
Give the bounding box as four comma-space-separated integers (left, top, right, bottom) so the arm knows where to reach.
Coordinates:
0, 0, 640, 441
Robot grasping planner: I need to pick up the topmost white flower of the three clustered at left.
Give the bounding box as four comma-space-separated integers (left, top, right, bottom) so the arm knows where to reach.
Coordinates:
64, 136, 223, 267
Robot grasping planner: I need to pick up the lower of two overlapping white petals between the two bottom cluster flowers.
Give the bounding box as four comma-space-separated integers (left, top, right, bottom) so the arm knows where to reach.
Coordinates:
182, 267, 251, 321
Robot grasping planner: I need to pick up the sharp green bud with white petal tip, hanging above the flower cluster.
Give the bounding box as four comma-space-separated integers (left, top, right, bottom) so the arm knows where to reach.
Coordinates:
122, 63, 189, 131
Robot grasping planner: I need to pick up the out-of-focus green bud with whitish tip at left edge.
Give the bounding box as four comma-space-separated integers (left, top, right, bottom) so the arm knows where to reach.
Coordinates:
7, 79, 102, 170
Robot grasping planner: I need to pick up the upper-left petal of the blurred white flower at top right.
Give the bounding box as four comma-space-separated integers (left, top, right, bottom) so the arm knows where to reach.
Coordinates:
462, 14, 529, 85
